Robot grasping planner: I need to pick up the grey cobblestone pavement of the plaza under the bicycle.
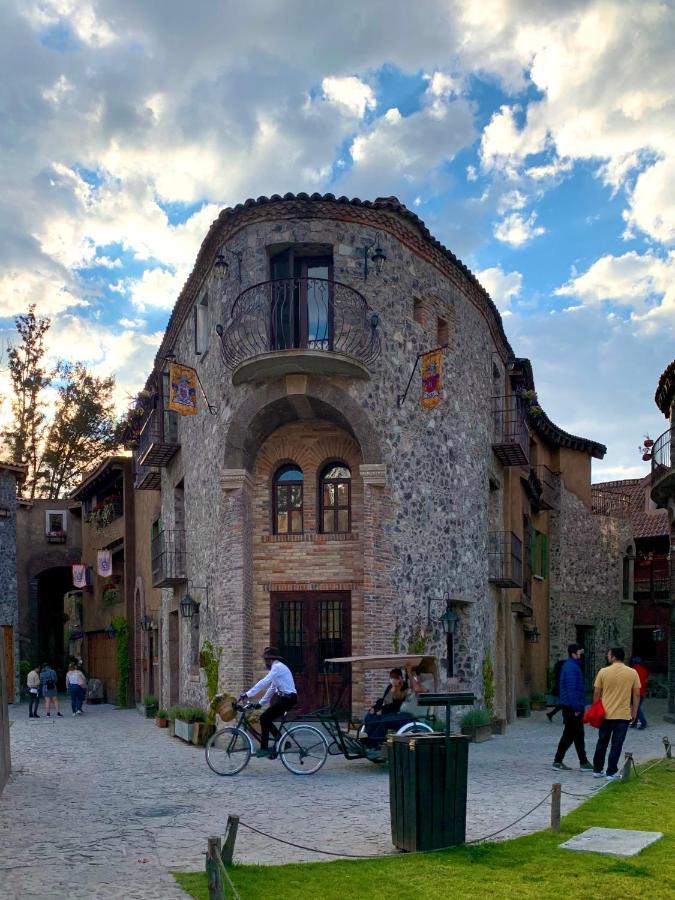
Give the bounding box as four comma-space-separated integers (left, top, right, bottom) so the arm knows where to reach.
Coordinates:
0, 701, 675, 900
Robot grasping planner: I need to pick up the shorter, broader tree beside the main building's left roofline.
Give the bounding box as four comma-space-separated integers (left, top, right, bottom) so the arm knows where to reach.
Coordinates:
41, 362, 119, 499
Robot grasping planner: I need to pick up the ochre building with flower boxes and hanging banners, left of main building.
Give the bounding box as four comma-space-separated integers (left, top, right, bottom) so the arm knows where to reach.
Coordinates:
68, 456, 159, 705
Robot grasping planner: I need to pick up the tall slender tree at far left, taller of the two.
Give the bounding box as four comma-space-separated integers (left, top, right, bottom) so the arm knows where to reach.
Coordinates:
2, 304, 53, 500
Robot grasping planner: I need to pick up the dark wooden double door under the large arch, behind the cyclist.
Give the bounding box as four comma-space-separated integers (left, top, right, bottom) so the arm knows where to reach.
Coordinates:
270, 591, 351, 713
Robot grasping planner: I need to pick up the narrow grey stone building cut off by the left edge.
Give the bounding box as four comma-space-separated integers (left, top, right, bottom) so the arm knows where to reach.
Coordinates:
0, 462, 26, 708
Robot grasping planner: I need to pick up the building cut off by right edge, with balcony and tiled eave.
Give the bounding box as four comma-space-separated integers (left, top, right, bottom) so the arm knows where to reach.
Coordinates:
651, 360, 675, 722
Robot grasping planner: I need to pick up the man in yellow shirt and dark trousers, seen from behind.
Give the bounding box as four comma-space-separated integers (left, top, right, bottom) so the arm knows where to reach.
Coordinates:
593, 647, 640, 781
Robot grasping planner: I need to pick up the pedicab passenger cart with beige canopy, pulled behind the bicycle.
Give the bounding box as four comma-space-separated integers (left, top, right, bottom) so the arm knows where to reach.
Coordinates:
312, 653, 439, 762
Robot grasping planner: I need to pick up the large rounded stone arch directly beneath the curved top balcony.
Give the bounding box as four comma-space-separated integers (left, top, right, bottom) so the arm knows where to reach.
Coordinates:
224, 376, 383, 472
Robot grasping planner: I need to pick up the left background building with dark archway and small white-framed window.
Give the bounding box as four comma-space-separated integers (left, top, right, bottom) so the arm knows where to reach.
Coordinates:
17, 498, 82, 687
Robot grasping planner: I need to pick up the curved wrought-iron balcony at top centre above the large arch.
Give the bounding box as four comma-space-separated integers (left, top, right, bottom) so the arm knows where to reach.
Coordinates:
218, 278, 381, 385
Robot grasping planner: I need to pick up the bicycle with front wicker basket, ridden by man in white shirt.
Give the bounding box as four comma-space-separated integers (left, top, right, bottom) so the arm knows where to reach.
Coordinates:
205, 703, 328, 775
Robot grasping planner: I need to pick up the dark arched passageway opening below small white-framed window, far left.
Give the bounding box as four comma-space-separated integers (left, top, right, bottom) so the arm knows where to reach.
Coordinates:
36, 566, 73, 687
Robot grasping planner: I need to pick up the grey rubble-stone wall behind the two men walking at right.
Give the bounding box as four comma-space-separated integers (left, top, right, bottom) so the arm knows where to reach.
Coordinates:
550, 479, 635, 668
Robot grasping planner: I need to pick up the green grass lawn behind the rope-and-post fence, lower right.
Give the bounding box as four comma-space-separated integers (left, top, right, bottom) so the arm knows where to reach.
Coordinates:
175, 760, 675, 900
